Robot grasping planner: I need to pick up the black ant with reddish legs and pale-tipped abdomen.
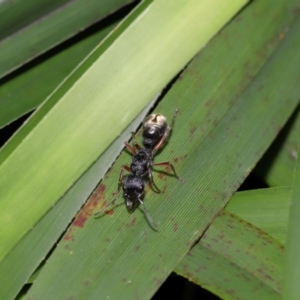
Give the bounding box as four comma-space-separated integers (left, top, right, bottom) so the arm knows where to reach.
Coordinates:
95, 109, 182, 230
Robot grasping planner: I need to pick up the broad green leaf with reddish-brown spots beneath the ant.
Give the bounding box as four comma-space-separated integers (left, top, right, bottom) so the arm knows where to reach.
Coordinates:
24, 2, 300, 299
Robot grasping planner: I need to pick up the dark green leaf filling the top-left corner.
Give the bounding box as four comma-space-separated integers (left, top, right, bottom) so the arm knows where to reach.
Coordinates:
0, 0, 132, 78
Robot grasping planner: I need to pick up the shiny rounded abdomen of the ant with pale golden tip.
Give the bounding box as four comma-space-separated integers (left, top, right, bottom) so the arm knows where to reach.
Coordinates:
143, 114, 167, 148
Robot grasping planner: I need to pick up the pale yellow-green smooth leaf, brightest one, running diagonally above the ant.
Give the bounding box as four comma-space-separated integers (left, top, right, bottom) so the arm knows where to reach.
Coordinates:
0, 0, 245, 270
